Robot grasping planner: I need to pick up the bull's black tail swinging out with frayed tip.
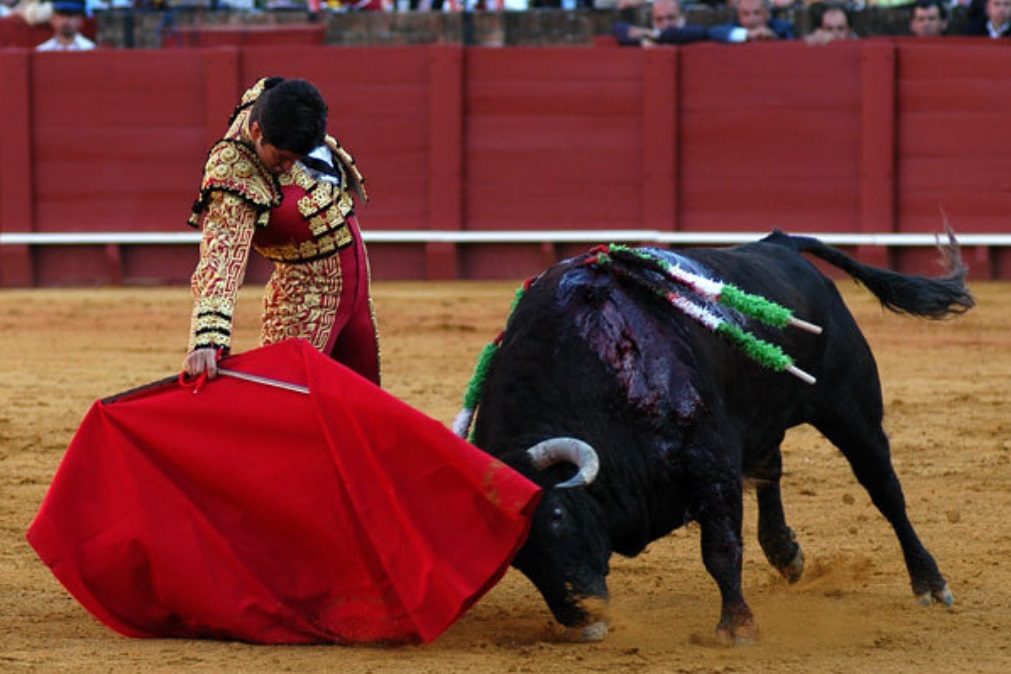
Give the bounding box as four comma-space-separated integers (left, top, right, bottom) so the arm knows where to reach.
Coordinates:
763, 227, 976, 319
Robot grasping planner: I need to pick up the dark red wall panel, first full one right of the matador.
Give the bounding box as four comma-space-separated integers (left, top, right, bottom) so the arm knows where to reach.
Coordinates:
464, 49, 643, 229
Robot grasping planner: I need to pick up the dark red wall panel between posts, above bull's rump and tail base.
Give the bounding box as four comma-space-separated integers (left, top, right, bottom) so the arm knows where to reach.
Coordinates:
680, 42, 860, 231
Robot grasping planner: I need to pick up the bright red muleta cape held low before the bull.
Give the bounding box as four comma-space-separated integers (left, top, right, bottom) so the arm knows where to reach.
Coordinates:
27, 340, 540, 644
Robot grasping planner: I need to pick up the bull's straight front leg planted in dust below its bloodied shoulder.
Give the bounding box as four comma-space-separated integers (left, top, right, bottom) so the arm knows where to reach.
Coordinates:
692, 478, 758, 644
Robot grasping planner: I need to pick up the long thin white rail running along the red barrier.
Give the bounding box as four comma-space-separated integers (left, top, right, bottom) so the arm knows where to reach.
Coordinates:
0, 229, 1011, 247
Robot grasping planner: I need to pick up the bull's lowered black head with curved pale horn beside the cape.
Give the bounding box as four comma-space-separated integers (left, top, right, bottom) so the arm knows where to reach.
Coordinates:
511, 438, 611, 641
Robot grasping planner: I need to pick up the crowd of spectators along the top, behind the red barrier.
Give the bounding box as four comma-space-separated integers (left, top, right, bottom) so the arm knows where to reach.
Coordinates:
0, 0, 1011, 51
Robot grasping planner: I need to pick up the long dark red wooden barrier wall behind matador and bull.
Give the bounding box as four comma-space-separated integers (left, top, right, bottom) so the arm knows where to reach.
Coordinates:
0, 39, 1011, 286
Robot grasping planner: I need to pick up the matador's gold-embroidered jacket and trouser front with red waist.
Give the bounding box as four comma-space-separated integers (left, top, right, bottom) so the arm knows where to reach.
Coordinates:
189, 80, 367, 351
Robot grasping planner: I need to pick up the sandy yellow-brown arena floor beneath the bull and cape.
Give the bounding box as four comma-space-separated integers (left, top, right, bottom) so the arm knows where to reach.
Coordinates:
0, 281, 1011, 674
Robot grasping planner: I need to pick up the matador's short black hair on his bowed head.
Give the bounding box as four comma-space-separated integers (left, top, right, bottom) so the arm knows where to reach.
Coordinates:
252, 78, 327, 156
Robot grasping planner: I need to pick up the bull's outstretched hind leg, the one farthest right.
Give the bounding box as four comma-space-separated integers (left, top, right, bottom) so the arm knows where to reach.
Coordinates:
815, 418, 954, 606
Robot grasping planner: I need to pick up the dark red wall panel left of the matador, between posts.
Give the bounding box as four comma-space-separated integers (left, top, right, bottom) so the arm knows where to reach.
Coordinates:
30, 51, 214, 231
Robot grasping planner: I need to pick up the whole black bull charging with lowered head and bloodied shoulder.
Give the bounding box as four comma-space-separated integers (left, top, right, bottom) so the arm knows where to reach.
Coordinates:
474, 232, 973, 641
